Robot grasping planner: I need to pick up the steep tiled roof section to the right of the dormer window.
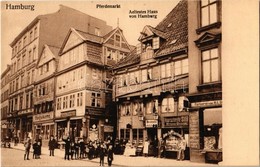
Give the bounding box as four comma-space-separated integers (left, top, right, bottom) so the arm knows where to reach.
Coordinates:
155, 0, 188, 57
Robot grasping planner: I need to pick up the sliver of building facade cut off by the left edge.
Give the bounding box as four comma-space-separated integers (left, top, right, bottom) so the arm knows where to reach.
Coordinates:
1, 65, 12, 141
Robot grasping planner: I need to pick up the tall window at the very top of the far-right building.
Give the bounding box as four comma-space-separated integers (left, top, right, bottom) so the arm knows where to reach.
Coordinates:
201, 0, 218, 27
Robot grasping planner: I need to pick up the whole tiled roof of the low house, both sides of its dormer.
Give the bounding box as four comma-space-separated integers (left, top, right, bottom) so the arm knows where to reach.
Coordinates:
115, 0, 188, 67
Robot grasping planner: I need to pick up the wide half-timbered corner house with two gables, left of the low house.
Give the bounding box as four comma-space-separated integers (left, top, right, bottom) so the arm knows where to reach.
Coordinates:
55, 27, 130, 141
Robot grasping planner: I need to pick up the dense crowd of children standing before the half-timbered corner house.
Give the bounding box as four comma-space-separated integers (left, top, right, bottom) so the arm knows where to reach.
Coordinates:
63, 137, 113, 166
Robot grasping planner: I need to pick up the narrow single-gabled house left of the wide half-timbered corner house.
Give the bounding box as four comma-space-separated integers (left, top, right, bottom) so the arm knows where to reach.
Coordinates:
33, 45, 59, 146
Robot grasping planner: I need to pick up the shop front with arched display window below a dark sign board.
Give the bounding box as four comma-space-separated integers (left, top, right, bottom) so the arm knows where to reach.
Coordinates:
162, 114, 190, 160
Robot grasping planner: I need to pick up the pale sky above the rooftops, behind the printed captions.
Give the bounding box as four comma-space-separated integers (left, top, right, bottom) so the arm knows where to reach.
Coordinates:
1, 0, 179, 72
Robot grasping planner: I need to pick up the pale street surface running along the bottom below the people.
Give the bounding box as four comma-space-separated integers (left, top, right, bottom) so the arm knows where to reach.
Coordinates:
1, 144, 218, 167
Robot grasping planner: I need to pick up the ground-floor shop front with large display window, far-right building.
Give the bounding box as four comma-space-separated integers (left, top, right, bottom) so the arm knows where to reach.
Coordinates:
189, 97, 222, 163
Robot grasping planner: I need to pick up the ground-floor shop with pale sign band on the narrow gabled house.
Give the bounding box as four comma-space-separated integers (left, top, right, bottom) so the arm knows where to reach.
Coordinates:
33, 112, 55, 147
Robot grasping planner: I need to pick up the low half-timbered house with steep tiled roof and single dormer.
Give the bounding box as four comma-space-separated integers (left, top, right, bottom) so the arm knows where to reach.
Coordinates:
114, 1, 189, 158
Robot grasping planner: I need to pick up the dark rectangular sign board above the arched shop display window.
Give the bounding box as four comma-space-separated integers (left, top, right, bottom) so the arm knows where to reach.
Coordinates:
164, 115, 189, 127
